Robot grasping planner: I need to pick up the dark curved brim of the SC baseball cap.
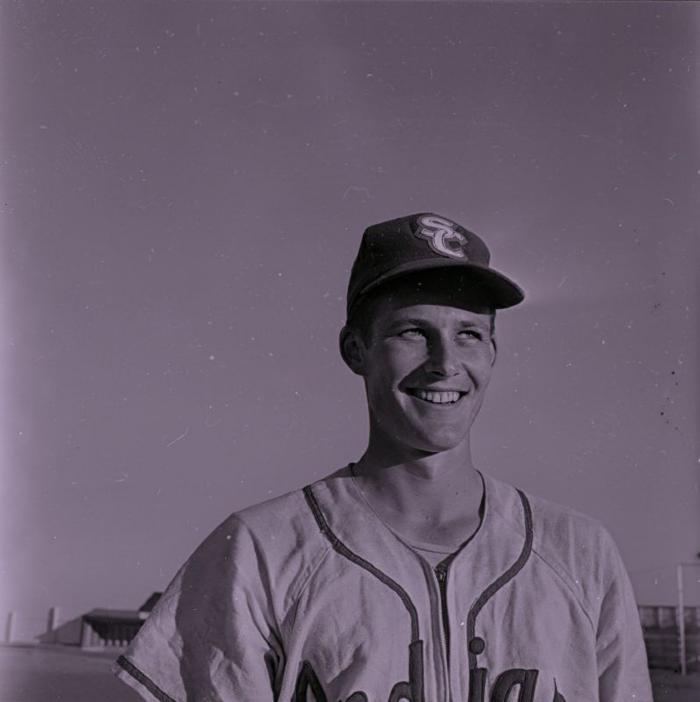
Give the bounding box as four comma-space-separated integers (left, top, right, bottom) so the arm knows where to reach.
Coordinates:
353, 259, 525, 309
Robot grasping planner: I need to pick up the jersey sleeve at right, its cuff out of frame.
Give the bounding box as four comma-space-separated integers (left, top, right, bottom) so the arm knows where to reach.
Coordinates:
596, 532, 652, 702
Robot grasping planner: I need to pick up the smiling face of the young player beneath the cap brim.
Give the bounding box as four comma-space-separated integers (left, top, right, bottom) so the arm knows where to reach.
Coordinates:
343, 278, 496, 454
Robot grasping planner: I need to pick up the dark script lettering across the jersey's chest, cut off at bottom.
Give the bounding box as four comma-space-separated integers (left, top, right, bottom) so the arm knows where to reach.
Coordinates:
292, 661, 566, 702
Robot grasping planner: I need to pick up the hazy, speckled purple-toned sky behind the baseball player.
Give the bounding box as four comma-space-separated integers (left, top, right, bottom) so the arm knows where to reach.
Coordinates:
0, 0, 700, 633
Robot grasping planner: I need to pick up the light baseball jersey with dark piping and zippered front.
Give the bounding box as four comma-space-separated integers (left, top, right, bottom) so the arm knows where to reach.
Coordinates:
115, 468, 652, 702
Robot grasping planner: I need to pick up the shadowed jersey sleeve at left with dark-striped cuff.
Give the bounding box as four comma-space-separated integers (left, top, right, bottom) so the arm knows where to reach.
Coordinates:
114, 516, 284, 702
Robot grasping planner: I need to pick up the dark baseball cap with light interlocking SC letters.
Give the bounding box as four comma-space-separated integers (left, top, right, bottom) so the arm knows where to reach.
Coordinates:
347, 212, 525, 317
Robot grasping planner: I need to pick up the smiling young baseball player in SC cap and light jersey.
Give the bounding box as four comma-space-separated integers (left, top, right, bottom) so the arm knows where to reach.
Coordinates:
116, 213, 652, 702
